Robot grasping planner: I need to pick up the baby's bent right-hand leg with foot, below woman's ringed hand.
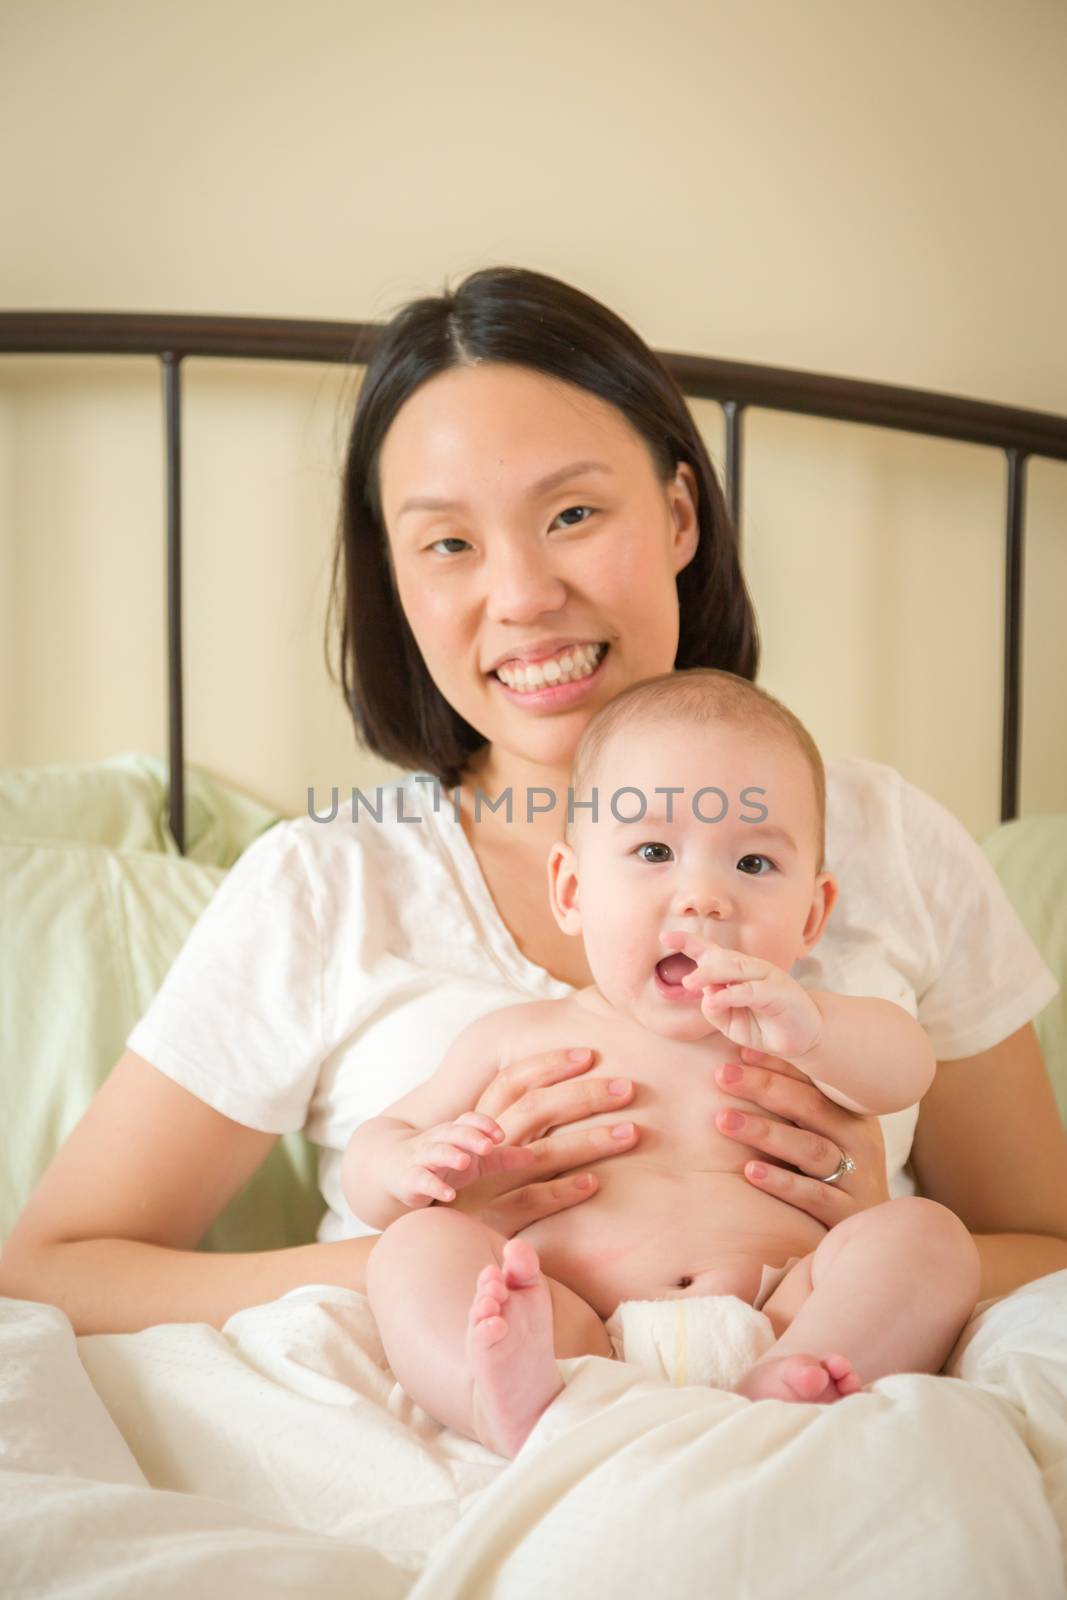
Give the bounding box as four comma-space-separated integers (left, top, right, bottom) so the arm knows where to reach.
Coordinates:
736, 1195, 981, 1402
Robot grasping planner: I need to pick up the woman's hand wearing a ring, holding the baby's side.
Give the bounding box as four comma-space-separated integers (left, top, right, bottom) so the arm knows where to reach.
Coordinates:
715, 1050, 889, 1229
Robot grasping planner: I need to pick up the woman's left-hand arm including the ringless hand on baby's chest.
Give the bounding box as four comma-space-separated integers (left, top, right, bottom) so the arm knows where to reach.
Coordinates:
0, 1050, 637, 1334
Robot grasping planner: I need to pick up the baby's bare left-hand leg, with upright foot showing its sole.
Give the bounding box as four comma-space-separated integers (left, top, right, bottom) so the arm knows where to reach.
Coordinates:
366, 1206, 611, 1456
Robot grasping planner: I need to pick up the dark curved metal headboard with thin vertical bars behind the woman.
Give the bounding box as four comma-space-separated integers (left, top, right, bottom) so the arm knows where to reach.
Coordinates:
0, 310, 1067, 854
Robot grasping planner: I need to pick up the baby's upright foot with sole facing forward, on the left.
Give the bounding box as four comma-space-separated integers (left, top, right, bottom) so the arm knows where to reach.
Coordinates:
467, 1238, 563, 1458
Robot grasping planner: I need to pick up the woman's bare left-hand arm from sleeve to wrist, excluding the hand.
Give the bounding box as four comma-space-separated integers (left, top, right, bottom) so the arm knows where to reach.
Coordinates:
0, 1050, 379, 1333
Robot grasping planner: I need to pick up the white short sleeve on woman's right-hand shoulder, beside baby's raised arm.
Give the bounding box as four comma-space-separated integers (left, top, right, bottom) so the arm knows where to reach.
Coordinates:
899, 778, 1059, 1061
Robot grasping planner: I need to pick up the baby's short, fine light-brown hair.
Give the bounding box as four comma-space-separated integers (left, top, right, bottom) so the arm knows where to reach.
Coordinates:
563, 667, 825, 872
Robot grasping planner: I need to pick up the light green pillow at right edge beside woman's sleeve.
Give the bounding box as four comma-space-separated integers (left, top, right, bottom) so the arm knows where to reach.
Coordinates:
982, 813, 1067, 1128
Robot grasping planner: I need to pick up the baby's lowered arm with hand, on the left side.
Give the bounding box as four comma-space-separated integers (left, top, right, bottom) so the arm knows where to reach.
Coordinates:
341, 1006, 534, 1229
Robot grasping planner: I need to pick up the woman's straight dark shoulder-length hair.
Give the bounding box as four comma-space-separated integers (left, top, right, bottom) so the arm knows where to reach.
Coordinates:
326, 267, 760, 787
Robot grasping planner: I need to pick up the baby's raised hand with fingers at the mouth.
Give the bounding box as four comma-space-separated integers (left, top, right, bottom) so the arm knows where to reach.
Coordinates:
659, 928, 822, 1061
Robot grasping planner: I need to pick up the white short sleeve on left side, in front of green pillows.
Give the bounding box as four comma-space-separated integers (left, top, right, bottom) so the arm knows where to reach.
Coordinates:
126, 822, 326, 1133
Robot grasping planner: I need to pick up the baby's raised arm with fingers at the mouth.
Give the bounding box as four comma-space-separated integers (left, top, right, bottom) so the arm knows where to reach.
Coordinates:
661, 930, 937, 1117
